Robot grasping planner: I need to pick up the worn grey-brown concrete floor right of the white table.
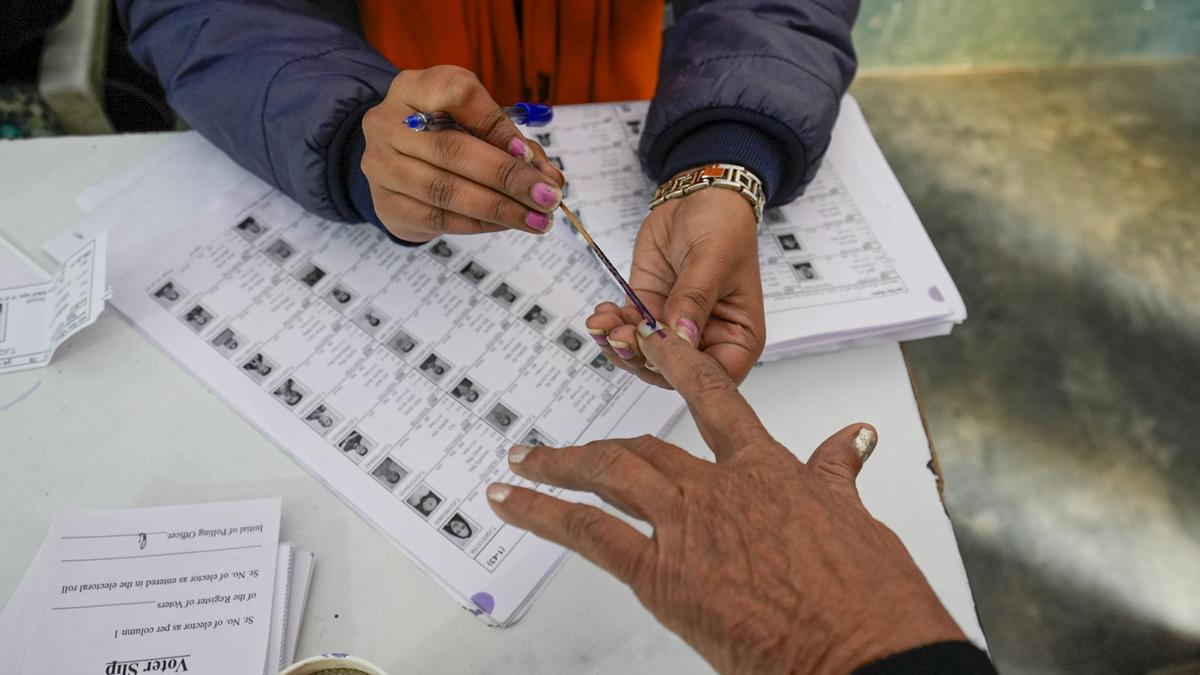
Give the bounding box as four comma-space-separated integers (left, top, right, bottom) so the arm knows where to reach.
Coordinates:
852, 61, 1200, 674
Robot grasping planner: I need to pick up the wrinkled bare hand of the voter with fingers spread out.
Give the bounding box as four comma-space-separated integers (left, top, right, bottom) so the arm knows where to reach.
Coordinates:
487, 324, 964, 673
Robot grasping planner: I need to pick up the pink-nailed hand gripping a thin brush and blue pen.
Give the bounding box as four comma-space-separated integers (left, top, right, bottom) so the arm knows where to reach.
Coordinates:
362, 66, 563, 241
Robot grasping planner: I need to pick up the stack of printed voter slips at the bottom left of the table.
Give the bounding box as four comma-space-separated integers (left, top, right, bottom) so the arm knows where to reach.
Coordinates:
0, 500, 313, 675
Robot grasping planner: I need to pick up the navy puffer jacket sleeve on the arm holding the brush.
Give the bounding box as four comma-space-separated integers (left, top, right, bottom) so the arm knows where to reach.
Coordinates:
116, 0, 397, 221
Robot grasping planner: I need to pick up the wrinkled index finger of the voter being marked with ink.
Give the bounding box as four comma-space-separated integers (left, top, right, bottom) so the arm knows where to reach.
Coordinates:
637, 322, 769, 461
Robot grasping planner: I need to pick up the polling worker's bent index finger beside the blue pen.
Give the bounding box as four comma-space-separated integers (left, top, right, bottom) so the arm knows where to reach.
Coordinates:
400, 66, 533, 153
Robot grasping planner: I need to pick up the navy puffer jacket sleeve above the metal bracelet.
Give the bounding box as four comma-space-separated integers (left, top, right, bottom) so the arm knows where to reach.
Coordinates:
640, 0, 859, 203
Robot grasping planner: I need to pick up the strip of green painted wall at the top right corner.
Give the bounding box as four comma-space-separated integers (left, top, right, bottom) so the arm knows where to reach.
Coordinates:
854, 0, 1200, 72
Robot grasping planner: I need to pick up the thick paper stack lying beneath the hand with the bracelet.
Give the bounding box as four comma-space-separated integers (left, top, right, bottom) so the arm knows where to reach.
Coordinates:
535, 96, 966, 360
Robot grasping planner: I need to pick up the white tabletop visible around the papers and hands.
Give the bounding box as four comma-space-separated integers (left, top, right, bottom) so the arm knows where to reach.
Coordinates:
0, 135, 983, 674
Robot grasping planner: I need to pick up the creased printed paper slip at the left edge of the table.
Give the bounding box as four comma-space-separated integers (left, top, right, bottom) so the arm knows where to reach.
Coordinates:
0, 232, 108, 374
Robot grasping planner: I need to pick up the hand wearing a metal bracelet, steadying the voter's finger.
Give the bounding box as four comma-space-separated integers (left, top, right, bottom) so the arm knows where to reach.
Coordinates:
587, 187, 767, 387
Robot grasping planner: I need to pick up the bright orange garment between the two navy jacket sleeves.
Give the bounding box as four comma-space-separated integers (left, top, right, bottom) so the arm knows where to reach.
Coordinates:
359, 0, 662, 104
